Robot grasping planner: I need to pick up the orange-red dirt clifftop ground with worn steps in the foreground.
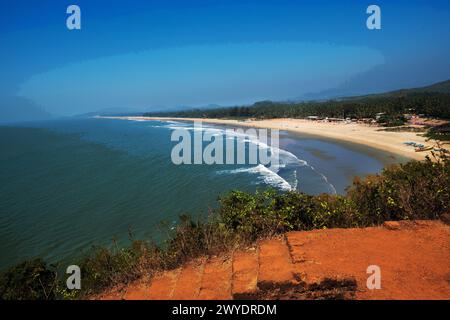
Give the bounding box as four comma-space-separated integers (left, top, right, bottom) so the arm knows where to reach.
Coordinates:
95, 221, 450, 300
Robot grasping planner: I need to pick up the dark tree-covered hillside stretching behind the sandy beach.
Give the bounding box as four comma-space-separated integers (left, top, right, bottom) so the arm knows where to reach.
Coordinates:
145, 80, 450, 120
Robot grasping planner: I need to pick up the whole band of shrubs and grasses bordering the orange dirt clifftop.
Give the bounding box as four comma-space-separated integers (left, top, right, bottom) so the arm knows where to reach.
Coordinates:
0, 154, 450, 299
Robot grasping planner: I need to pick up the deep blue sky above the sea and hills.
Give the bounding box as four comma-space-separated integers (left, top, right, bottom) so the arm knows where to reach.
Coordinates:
0, 0, 450, 119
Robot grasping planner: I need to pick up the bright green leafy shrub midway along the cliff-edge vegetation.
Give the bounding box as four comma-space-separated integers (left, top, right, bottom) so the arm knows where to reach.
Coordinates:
218, 189, 361, 235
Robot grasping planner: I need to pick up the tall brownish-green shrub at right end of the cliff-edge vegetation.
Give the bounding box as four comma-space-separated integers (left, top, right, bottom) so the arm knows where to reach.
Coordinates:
347, 157, 450, 224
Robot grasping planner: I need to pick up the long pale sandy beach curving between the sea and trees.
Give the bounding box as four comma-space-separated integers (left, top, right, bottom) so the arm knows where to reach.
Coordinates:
105, 117, 440, 160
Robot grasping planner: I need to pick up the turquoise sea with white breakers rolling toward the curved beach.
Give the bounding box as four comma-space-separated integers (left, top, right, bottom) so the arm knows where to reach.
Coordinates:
0, 119, 405, 269
